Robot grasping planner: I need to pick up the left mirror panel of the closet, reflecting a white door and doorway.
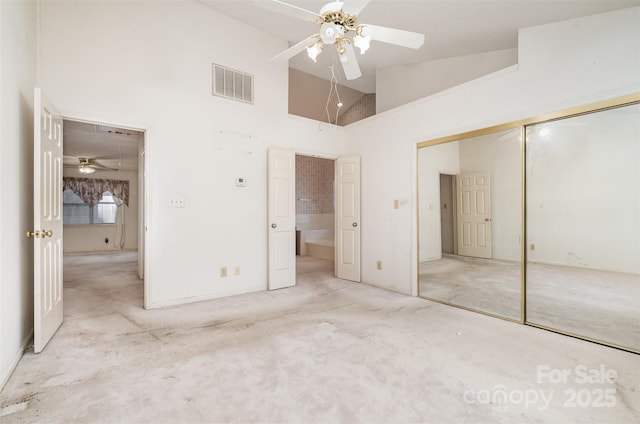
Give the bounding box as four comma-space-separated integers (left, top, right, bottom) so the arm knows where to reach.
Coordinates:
418, 128, 522, 320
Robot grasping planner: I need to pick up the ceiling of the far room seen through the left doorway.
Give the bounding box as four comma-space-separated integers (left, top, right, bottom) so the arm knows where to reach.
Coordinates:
62, 120, 144, 175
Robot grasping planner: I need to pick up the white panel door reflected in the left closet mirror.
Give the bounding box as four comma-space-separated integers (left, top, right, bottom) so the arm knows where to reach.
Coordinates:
456, 172, 491, 258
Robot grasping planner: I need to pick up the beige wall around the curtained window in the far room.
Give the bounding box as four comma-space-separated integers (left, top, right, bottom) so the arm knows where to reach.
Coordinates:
64, 168, 138, 253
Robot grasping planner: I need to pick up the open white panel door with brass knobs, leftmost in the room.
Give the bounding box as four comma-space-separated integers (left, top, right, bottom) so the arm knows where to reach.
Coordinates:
27, 88, 63, 353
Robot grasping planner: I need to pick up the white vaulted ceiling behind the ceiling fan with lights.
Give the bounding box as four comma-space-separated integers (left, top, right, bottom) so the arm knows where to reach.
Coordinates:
199, 0, 640, 93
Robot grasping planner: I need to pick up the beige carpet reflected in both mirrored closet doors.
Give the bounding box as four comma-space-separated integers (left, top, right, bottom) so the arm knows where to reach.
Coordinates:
419, 255, 640, 350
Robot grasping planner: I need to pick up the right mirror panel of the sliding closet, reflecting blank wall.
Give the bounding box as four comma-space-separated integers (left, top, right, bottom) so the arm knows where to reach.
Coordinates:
526, 104, 640, 351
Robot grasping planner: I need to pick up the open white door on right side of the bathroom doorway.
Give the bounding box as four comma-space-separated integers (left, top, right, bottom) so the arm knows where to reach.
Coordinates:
335, 156, 360, 282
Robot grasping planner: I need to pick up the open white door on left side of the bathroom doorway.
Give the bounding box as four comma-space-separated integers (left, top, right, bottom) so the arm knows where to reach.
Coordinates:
267, 149, 296, 290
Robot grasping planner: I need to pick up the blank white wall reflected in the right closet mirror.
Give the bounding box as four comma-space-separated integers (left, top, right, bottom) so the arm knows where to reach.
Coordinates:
527, 105, 640, 274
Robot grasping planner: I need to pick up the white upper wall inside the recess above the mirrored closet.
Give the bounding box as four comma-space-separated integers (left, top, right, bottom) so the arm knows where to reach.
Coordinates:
376, 49, 518, 113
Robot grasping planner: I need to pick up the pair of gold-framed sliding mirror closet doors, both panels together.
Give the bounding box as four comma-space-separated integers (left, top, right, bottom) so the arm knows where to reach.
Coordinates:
417, 95, 640, 353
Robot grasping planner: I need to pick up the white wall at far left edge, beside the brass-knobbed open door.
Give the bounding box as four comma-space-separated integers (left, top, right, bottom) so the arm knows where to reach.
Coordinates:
0, 1, 36, 388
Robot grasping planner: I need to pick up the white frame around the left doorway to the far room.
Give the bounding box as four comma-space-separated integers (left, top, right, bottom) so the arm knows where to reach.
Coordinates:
61, 111, 152, 309
